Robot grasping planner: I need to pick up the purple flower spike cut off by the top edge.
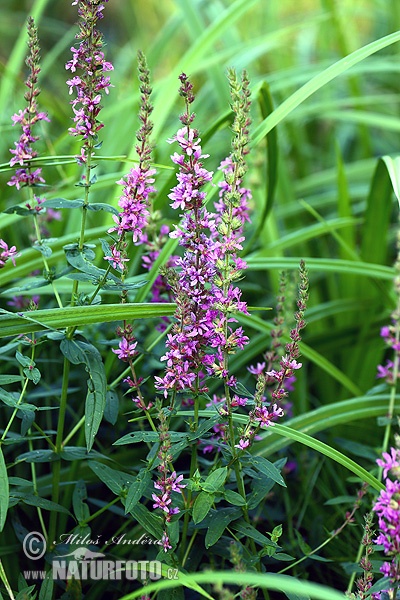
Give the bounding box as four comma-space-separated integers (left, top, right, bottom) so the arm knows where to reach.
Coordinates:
65, 0, 113, 164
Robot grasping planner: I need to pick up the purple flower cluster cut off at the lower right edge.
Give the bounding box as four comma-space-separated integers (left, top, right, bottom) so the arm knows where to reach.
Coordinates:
373, 448, 400, 588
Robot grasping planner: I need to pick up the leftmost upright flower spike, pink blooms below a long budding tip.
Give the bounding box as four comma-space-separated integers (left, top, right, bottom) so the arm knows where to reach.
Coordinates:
8, 17, 50, 190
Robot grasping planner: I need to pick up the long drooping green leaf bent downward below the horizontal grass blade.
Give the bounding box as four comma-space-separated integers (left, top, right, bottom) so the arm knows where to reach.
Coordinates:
60, 338, 107, 450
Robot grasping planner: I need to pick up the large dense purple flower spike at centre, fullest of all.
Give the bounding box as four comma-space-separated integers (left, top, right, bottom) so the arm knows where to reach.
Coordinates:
155, 74, 216, 397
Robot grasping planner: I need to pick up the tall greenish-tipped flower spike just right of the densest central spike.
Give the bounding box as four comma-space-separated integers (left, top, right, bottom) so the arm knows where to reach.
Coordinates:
204, 70, 251, 384
